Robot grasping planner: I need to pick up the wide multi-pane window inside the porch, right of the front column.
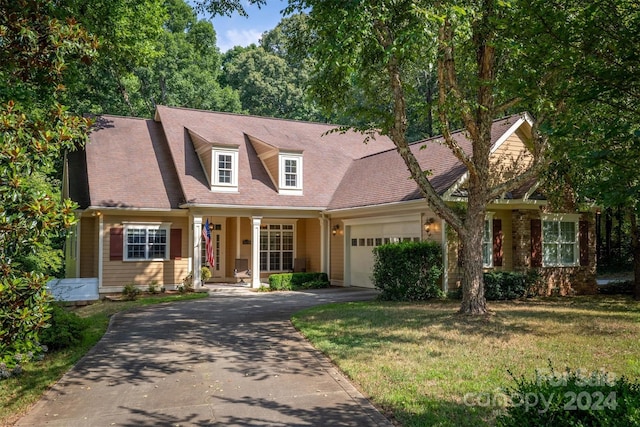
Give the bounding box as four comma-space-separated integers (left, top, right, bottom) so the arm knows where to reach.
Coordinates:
260, 224, 294, 271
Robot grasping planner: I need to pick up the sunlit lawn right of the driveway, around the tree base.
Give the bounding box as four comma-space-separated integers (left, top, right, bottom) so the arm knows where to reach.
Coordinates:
292, 296, 640, 426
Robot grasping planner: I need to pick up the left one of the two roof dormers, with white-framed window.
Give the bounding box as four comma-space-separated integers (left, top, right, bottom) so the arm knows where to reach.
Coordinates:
189, 130, 240, 193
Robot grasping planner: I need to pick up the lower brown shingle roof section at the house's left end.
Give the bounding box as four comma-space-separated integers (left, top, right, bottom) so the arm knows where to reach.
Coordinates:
69, 116, 184, 209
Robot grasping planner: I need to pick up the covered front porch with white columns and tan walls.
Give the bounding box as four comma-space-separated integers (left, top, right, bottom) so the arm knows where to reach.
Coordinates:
188, 209, 330, 288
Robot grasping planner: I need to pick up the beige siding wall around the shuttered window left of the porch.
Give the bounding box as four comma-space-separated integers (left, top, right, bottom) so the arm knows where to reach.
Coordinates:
102, 216, 190, 289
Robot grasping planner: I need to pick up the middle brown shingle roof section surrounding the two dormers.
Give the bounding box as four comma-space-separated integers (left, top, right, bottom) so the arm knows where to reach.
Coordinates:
156, 106, 393, 208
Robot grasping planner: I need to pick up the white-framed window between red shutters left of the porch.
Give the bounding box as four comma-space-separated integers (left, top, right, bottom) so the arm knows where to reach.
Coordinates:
124, 223, 171, 261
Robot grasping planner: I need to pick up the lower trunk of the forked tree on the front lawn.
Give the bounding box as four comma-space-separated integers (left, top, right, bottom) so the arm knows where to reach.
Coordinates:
460, 194, 487, 314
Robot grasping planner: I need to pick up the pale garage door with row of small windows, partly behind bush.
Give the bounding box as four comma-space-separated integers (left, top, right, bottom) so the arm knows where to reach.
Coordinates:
346, 220, 420, 288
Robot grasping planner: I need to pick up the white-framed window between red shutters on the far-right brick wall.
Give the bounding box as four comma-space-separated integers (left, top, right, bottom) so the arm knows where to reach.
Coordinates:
542, 215, 579, 267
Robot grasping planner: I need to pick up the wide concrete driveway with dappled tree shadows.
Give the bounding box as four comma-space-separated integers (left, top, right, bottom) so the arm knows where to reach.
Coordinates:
17, 288, 391, 427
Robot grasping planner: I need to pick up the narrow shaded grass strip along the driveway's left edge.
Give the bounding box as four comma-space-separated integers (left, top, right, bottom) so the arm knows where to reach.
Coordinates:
0, 293, 207, 426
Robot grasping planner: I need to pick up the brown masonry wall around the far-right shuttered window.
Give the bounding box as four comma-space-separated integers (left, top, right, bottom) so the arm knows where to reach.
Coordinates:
511, 210, 597, 295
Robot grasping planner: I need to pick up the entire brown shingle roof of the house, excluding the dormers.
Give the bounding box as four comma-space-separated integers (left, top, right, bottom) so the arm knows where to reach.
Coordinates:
69, 106, 520, 209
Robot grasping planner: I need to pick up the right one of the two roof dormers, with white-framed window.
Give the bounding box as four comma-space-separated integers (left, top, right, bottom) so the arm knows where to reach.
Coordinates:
247, 135, 303, 196
